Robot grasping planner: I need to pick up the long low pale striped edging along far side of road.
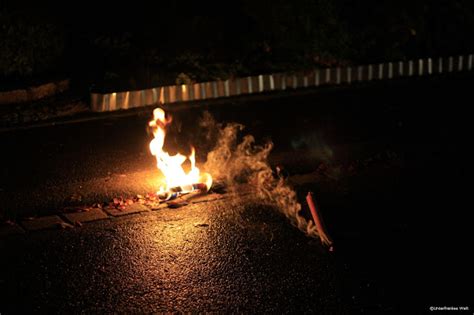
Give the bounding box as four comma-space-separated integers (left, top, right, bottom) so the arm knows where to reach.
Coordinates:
91, 54, 474, 112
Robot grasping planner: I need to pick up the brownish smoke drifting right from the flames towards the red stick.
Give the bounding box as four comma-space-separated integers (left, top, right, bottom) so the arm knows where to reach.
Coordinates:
200, 112, 318, 237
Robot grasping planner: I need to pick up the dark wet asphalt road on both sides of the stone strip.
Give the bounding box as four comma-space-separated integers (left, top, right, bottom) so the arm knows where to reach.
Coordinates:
0, 76, 473, 314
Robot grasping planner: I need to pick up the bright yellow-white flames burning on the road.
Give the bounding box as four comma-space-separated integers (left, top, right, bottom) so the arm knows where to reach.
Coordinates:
148, 108, 212, 195
